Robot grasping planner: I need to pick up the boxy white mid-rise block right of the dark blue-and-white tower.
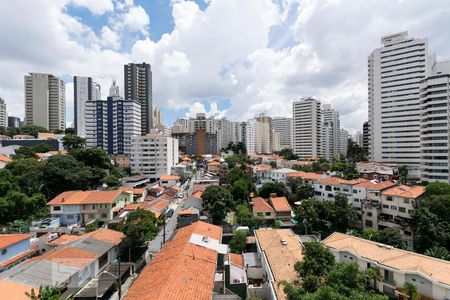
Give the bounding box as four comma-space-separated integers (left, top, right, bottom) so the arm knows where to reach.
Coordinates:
131, 130, 179, 180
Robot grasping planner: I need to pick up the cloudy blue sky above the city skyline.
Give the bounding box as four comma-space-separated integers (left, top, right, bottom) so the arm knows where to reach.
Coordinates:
0, 0, 450, 133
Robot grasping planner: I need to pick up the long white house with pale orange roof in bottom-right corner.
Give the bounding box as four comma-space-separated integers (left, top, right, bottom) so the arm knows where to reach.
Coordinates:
323, 232, 450, 300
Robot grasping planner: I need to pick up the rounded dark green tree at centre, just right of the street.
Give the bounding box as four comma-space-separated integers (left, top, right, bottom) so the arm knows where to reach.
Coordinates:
201, 185, 235, 224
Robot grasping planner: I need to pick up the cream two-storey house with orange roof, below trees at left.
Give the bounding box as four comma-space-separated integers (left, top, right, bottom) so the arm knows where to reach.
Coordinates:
47, 189, 133, 226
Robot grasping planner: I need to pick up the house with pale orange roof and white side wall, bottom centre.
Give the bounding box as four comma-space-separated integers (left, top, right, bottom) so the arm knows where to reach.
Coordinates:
253, 229, 303, 300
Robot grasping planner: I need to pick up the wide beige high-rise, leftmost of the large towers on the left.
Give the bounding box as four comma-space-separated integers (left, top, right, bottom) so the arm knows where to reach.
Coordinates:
25, 73, 66, 131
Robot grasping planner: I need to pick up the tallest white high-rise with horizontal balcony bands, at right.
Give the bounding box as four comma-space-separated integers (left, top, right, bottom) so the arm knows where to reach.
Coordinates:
368, 32, 432, 179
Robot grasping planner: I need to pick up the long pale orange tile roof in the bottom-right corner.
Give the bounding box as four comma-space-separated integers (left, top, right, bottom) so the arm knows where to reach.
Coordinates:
323, 232, 450, 286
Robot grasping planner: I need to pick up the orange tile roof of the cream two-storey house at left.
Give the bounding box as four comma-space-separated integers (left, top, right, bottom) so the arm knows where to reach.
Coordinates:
47, 189, 125, 205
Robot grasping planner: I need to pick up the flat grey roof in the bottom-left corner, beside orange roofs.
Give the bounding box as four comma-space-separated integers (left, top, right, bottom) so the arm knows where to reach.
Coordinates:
0, 259, 78, 288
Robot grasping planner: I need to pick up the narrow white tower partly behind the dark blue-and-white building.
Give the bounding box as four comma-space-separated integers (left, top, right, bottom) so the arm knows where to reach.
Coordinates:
73, 76, 101, 137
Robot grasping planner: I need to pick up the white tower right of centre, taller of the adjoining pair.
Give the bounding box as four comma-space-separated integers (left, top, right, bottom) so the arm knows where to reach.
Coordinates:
292, 98, 322, 158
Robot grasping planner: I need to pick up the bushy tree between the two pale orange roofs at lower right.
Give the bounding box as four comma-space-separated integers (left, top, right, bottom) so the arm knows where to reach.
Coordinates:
294, 242, 335, 278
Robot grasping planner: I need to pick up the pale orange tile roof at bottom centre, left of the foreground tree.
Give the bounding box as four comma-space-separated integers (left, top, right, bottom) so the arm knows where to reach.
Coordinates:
255, 229, 303, 299
